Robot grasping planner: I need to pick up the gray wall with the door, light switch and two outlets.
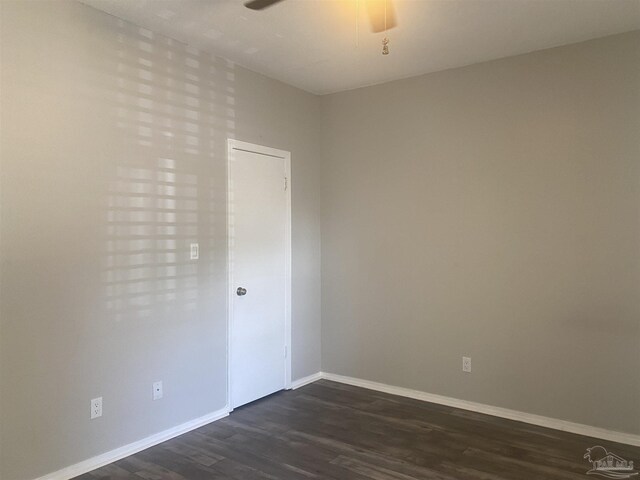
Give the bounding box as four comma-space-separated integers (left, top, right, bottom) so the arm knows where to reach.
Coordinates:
0, 1, 320, 480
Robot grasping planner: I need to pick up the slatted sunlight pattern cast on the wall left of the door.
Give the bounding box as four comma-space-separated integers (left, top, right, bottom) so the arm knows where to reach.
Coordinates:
103, 20, 235, 322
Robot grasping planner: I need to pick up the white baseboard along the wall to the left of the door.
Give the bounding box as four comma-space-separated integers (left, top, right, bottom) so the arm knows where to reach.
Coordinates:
36, 407, 229, 480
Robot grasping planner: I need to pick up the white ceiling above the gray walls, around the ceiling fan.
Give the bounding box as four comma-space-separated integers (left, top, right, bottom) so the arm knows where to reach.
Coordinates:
81, 0, 640, 94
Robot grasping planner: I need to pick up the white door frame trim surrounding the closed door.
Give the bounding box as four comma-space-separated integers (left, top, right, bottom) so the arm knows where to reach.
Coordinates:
227, 138, 291, 411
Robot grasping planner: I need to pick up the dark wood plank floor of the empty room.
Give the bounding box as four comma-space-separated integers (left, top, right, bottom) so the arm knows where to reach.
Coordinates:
76, 380, 640, 480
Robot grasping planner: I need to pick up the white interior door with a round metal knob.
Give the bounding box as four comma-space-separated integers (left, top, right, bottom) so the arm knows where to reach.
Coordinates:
229, 141, 290, 408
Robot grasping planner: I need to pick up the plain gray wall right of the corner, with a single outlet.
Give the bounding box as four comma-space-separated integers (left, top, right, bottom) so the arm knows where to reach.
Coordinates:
322, 32, 640, 434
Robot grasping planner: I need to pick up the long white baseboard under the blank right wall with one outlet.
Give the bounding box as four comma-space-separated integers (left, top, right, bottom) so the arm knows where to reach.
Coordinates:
320, 372, 640, 446
